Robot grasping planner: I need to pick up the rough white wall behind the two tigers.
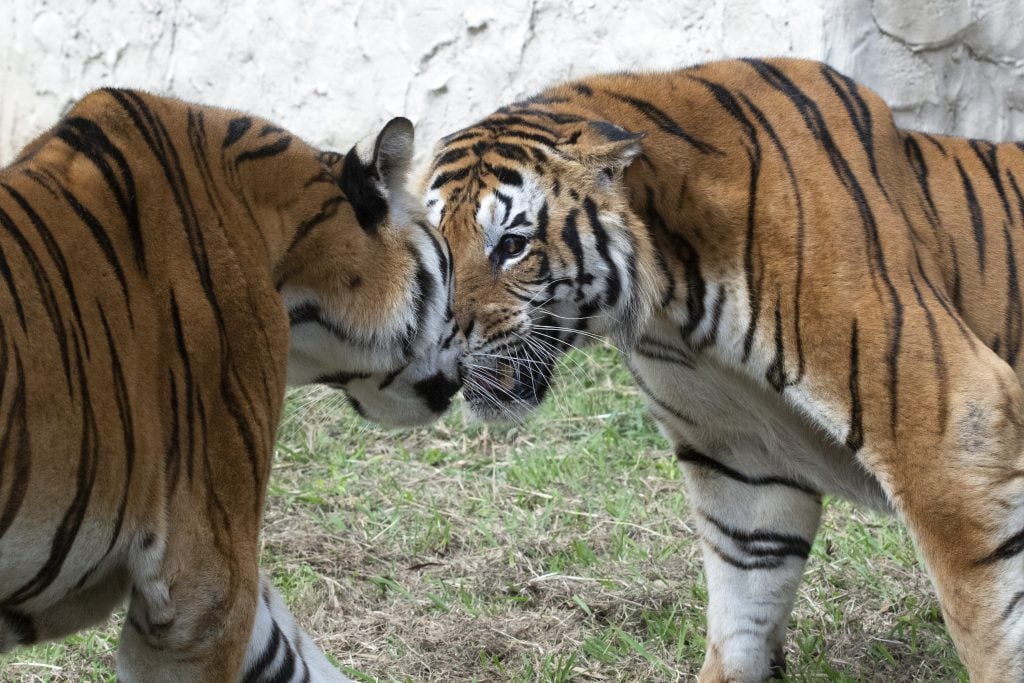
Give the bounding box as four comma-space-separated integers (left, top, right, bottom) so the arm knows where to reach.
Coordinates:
0, 0, 1024, 164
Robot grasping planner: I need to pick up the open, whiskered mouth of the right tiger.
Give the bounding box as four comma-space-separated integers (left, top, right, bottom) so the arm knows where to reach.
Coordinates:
462, 346, 555, 420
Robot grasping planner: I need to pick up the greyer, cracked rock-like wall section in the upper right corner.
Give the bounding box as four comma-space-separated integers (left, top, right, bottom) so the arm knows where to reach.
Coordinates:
823, 0, 1024, 140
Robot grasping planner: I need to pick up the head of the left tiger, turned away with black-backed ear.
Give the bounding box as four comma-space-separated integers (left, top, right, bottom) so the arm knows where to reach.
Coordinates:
268, 118, 464, 426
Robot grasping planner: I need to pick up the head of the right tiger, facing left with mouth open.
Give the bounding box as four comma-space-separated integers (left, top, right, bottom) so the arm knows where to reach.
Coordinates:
423, 105, 654, 420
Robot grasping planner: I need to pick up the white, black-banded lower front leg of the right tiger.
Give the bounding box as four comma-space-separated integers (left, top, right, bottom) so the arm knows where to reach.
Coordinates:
677, 446, 821, 683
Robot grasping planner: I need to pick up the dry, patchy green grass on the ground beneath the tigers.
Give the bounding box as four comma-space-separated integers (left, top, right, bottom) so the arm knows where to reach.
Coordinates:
0, 348, 967, 682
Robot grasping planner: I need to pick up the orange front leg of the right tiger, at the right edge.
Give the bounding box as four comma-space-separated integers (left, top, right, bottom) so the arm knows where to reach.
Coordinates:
861, 349, 1024, 682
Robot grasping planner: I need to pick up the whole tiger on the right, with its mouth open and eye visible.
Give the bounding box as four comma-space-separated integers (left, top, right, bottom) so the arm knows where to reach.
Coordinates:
423, 59, 1024, 682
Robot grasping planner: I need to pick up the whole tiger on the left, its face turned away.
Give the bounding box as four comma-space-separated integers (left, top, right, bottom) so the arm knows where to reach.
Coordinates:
0, 88, 464, 683
